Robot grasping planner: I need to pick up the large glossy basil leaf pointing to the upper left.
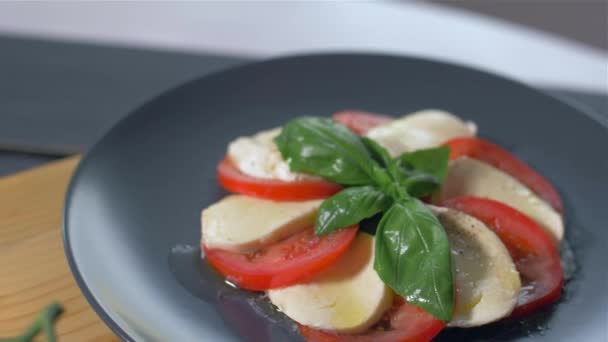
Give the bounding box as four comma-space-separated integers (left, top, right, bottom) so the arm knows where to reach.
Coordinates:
275, 117, 378, 185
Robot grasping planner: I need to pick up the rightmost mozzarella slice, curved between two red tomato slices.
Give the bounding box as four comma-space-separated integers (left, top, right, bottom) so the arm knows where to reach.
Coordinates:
439, 157, 564, 241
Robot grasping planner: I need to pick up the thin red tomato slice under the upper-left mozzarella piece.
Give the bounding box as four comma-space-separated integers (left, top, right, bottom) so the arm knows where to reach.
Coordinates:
217, 158, 342, 201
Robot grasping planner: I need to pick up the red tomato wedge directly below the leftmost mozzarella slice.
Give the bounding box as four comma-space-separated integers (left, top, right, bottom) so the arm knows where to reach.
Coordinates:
201, 226, 358, 291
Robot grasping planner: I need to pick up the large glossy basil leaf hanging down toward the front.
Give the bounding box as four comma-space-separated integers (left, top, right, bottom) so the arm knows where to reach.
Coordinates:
374, 199, 454, 321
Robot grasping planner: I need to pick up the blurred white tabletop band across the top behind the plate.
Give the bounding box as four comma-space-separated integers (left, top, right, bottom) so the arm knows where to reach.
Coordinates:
0, 1, 608, 93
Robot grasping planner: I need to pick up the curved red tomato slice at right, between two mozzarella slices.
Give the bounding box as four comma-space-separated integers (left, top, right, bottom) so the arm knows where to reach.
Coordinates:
441, 196, 563, 317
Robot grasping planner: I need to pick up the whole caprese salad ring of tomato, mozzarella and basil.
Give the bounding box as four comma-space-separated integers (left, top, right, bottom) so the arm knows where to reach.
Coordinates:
201, 110, 564, 342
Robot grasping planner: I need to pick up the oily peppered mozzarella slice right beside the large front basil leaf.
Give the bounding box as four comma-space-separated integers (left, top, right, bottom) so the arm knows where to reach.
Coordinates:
433, 207, 521, 327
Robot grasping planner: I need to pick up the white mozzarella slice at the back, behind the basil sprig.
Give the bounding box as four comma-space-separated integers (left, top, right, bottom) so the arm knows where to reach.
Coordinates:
366, 110, 477, 157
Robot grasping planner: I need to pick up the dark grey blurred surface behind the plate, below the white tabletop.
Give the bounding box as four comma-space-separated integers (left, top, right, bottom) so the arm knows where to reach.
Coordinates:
0, 36, 608, 175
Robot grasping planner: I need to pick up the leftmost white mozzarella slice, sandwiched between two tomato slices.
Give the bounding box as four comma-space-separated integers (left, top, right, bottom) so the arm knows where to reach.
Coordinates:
201, 195, 321, 252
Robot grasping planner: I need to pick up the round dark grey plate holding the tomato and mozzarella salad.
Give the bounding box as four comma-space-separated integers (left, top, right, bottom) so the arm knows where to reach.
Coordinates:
64, 54, 608, 341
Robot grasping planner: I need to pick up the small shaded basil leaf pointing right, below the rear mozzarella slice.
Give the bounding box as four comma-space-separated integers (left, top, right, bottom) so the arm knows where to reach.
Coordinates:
397, 146, 450, 184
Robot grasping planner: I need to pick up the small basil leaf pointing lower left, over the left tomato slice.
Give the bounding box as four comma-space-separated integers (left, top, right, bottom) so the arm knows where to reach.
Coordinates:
315, 186, 392, 235
